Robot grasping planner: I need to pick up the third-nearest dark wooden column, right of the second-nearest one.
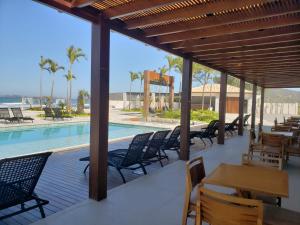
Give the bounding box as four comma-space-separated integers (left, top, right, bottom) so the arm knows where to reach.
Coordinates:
218, 73, 227, 144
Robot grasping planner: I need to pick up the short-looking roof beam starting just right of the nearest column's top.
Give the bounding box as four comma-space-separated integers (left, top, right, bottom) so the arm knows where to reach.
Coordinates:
104, 0, 182, 19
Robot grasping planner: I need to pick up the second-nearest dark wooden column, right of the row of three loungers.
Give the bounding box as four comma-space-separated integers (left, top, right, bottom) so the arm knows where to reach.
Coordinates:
180, 58, 192, 160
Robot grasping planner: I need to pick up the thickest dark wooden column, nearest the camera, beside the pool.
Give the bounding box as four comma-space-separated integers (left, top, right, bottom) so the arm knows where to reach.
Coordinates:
89, 18, 110, 201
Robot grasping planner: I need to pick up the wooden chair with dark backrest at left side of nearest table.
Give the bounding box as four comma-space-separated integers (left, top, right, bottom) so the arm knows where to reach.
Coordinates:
182, 157, 205, 225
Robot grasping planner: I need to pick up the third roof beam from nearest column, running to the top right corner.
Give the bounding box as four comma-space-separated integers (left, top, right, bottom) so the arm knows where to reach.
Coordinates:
143, 2, 300, 37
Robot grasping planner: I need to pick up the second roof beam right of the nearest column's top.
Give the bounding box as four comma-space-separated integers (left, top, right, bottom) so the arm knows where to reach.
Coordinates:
126, 0, 270, 29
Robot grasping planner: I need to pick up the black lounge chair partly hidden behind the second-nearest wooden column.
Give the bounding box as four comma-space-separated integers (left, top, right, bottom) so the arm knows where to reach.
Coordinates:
161, 126, 180, 159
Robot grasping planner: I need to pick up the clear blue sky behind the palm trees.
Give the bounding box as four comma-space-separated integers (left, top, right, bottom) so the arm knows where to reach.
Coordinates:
0, 0, 180, 97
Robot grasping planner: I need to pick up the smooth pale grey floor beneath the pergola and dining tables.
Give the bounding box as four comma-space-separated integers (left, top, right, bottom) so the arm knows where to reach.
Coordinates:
34, 132, 300, 225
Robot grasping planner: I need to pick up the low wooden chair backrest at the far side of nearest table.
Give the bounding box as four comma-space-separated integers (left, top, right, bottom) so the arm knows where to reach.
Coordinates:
242, 154, 282, 170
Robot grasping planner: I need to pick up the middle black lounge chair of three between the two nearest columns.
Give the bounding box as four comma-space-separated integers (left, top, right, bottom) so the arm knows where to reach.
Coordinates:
142, 130, 170, 167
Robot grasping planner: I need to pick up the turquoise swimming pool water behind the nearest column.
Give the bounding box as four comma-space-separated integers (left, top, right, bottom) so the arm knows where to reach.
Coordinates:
0, 122, 161, 158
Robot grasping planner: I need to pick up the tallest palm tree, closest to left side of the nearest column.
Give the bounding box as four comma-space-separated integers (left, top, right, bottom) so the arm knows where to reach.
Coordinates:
67, 45, 86, 110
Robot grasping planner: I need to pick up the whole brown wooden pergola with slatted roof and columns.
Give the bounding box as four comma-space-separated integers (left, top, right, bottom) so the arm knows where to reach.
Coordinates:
36, 0, 300, 200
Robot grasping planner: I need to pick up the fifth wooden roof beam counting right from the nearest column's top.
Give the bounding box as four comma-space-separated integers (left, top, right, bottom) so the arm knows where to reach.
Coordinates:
171, 25, 300, 50
